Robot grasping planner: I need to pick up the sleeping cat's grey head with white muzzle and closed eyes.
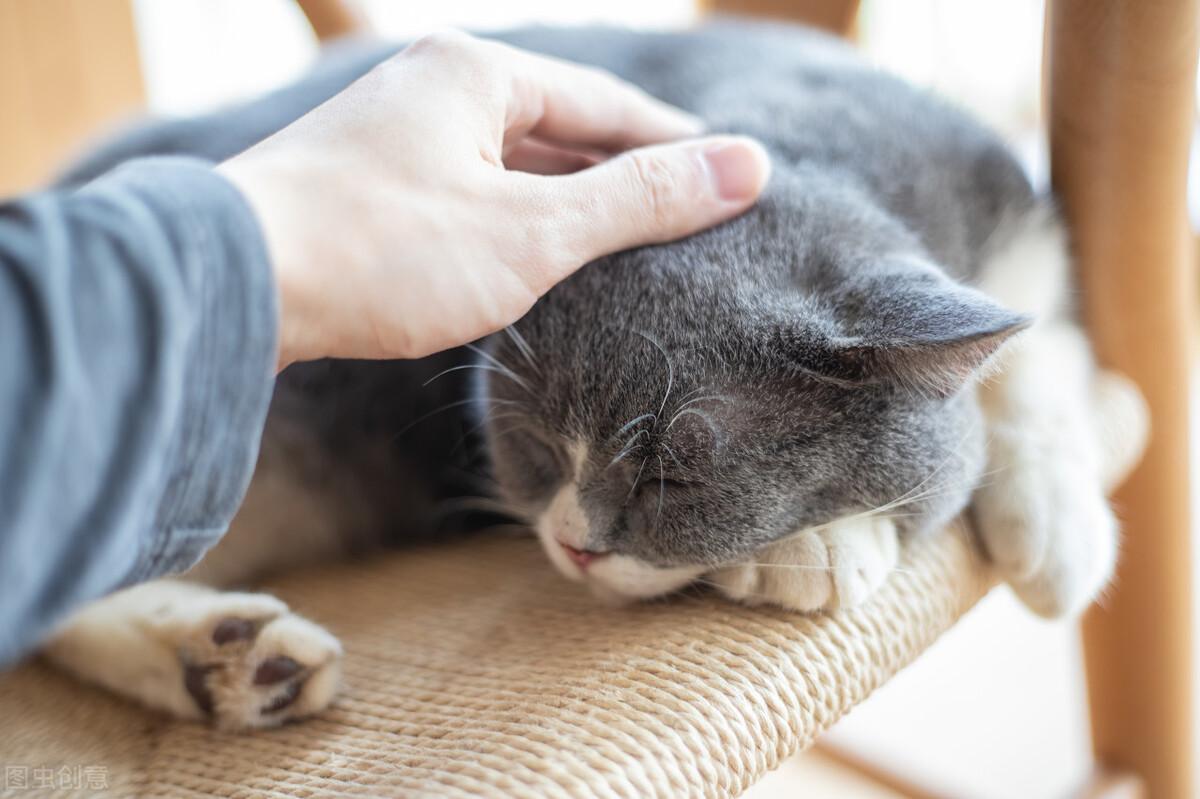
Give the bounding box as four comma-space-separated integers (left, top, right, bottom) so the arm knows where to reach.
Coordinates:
485, 184, 1025, 597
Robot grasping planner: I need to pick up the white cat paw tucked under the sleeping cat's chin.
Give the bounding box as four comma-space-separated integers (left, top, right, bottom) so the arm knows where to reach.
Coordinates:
709, 516, 900, 613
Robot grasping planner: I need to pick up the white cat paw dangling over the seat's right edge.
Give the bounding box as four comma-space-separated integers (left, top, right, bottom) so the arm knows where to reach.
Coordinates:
972, 431, 1117, 618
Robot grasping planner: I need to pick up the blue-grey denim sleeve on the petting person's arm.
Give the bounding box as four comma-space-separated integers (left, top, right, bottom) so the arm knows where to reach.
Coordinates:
0, 158, 277, 666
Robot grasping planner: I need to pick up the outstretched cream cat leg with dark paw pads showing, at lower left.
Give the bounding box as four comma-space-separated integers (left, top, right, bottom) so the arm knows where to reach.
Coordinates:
44, 579, 342, 729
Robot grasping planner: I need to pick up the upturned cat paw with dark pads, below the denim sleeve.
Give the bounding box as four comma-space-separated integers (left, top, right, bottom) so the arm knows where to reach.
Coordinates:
164, 593, 342, 729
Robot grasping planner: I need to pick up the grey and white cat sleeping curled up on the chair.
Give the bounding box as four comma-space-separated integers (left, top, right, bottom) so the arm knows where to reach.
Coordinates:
39, 22, 1145, 728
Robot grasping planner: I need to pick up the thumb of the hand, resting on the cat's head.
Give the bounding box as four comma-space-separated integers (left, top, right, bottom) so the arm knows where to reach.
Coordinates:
548, 136, 770, 263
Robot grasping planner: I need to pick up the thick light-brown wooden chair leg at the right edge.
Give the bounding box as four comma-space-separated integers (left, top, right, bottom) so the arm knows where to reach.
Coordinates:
1048, 0, 1196, 799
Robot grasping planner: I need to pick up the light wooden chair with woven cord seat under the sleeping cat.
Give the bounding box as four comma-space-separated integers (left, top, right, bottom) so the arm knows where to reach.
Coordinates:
0, 0, 1198, 799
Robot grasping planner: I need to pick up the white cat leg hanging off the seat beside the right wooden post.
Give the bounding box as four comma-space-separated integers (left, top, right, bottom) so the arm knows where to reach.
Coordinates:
972, 323, 1147, 617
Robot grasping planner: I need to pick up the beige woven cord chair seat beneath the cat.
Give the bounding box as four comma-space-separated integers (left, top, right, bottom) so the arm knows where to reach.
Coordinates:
0, 520, 992, 799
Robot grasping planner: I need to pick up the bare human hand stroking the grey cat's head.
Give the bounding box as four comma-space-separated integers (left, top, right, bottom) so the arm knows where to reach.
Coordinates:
218, 34, 769, 368
